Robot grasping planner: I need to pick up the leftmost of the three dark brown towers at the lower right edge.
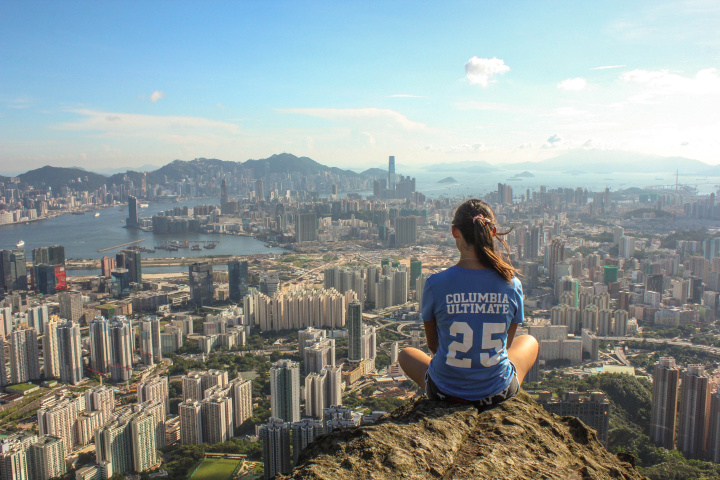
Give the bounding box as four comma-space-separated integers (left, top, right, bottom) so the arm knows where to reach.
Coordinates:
650, 357, 680, 450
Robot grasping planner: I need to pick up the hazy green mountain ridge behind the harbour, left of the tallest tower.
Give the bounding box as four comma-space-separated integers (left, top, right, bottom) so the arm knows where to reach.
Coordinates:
0, 153, 387, 191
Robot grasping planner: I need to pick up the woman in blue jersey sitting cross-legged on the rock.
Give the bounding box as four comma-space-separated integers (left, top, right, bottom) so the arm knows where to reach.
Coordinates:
399, 200, 538, 405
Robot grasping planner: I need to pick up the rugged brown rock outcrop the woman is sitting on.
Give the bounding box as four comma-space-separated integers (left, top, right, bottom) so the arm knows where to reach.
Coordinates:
277, 392, 645, 480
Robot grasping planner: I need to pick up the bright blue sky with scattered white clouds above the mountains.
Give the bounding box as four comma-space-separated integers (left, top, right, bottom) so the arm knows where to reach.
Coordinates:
0, 0, 720, 171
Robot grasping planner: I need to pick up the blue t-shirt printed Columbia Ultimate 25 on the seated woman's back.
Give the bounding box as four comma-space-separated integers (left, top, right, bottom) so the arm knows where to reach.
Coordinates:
422, 266, 523, 401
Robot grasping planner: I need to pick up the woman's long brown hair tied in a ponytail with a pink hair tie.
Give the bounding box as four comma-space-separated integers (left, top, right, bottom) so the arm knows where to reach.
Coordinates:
453, 199, 518, 282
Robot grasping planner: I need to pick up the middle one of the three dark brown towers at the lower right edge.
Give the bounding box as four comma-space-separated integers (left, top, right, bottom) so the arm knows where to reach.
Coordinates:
677, 365, 711, 459
